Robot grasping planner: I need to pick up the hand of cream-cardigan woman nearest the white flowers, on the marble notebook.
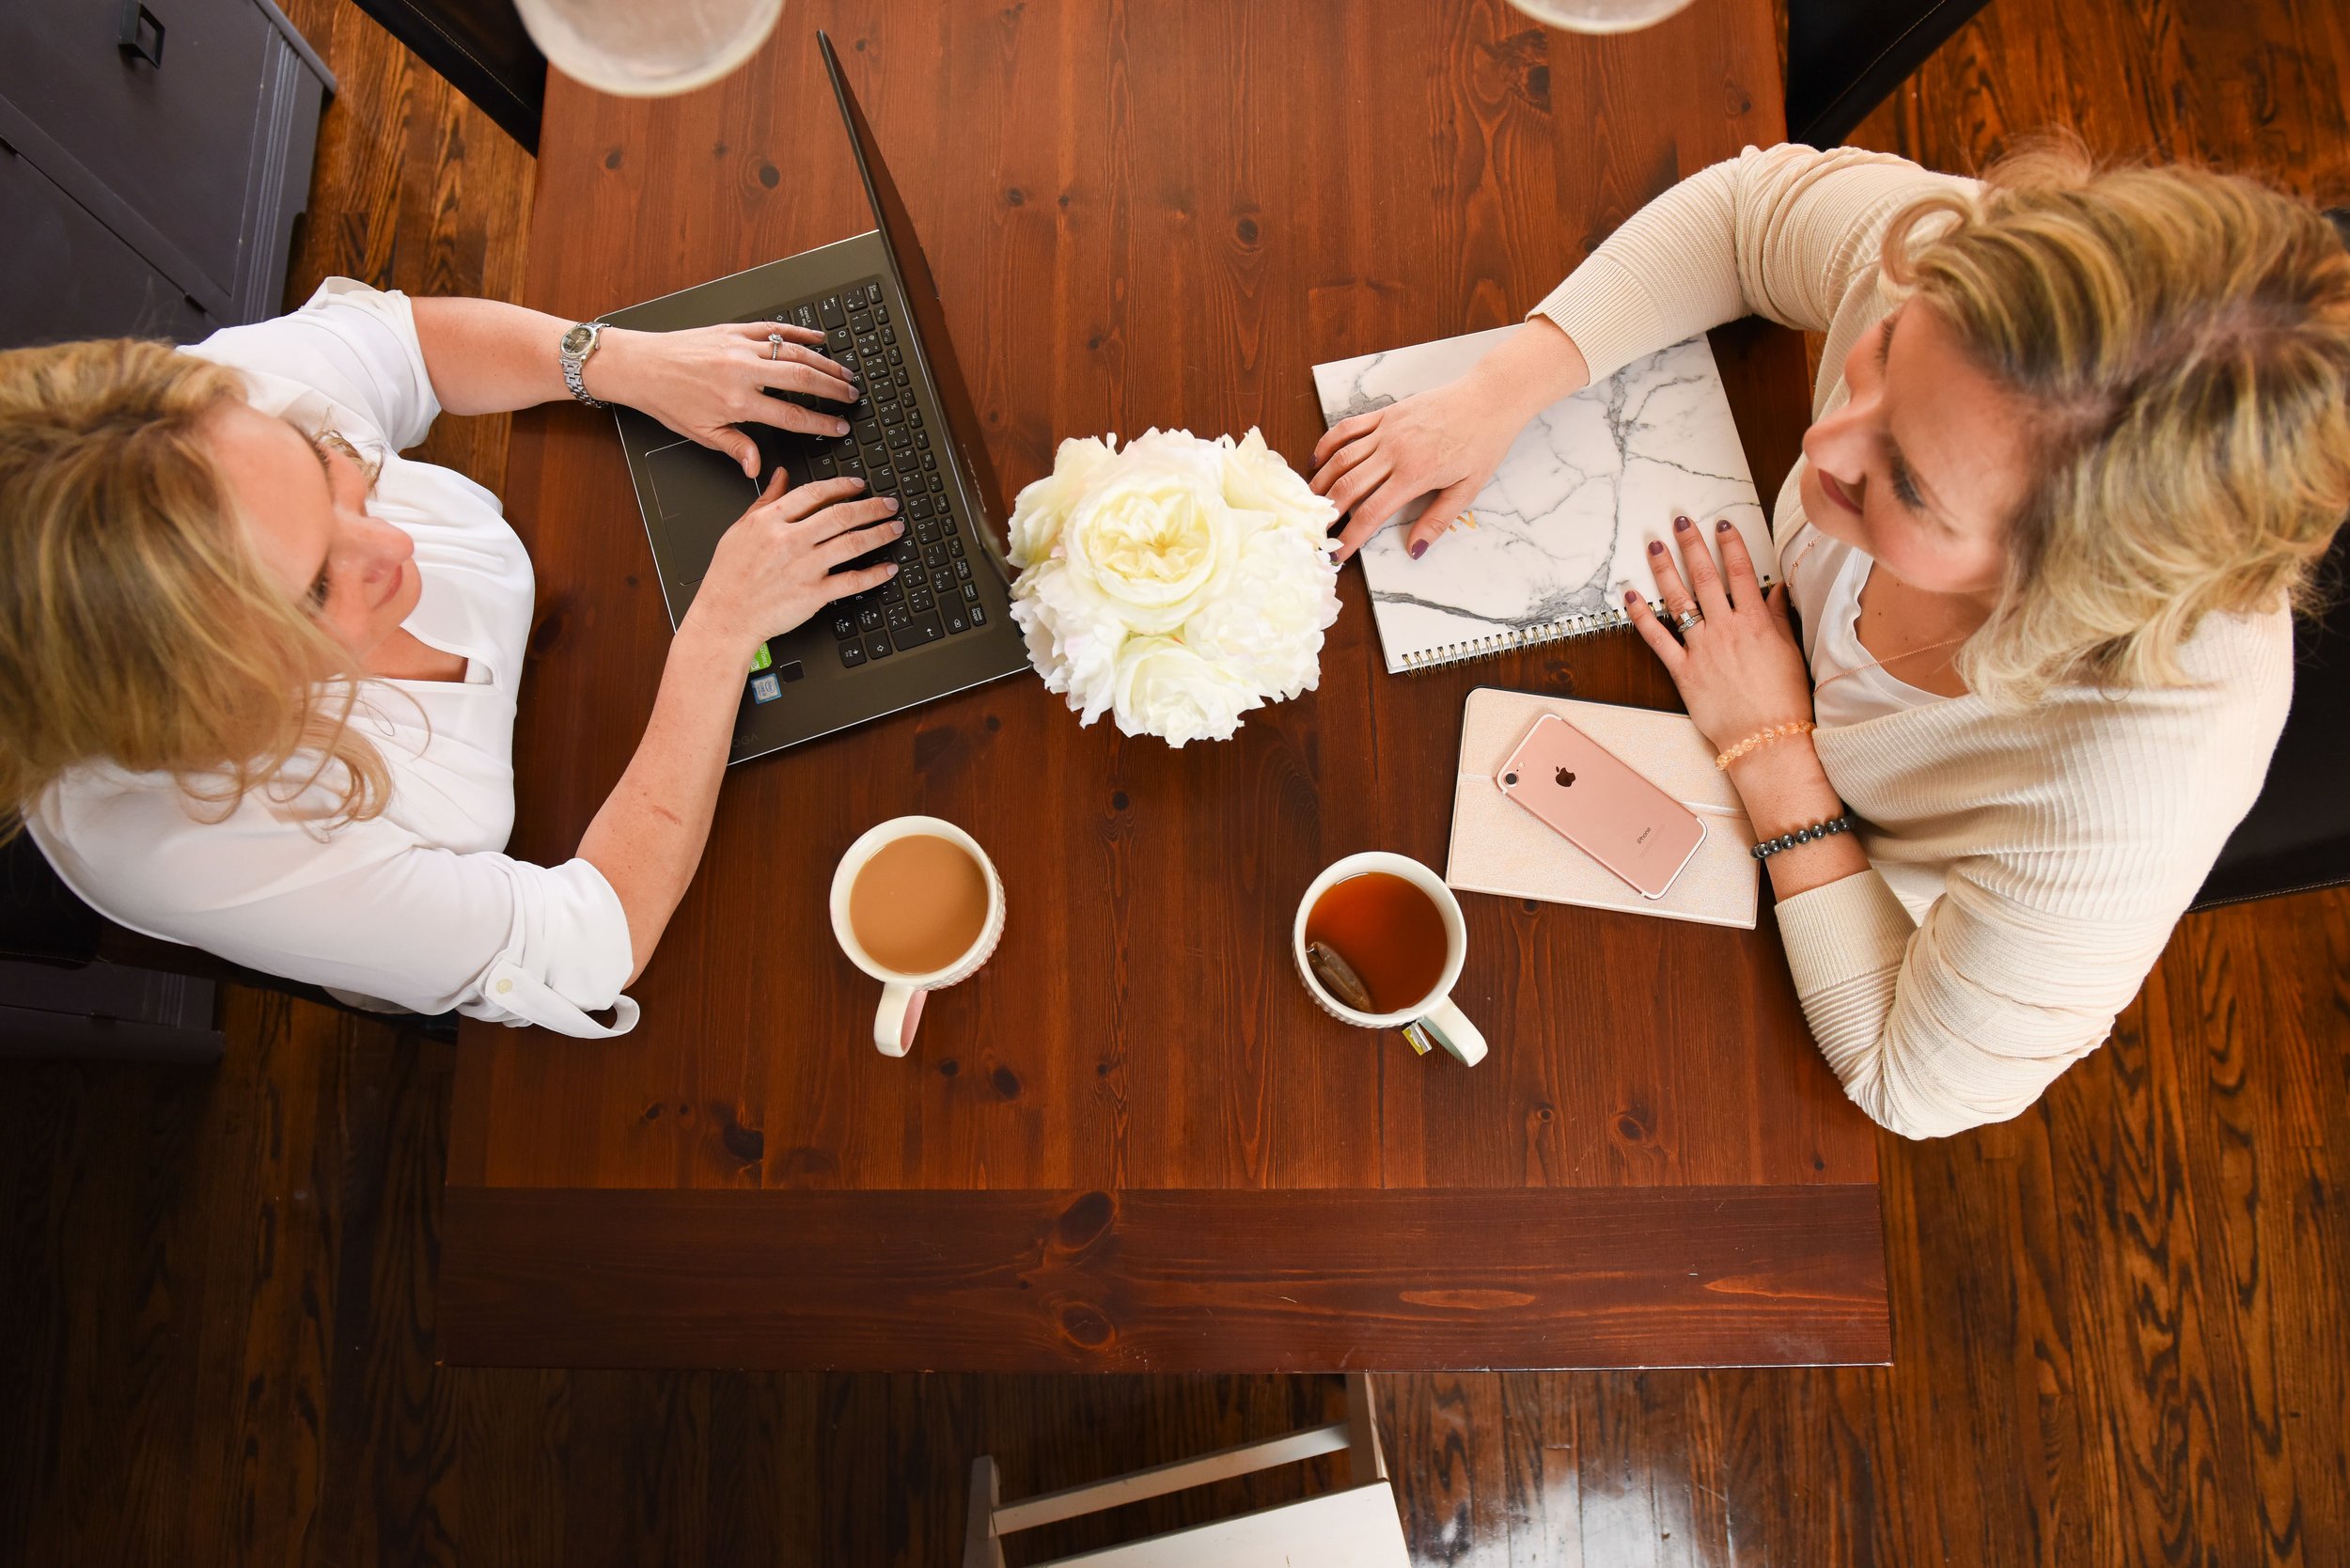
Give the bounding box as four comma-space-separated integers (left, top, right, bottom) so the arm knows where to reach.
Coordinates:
1314, 315, 1589, 559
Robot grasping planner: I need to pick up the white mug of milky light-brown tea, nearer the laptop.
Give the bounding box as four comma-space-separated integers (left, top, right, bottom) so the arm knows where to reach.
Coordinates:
832, 816, 1004, 1056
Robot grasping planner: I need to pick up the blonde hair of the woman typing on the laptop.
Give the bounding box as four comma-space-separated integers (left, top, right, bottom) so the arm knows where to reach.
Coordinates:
0, 338, 390, 837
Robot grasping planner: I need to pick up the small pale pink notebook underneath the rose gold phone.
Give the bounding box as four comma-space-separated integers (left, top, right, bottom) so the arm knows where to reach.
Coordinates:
1429, 682, 1762, 931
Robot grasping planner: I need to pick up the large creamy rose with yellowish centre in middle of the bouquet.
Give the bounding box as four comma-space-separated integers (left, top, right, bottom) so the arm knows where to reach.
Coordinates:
1058, 431, 1239, 635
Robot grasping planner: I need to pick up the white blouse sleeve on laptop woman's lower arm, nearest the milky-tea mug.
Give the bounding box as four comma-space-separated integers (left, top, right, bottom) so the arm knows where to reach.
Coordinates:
31, 797, 637, 1037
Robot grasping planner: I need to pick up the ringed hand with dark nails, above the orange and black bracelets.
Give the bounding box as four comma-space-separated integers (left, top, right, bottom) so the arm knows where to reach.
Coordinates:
1624, 517, 1812, 750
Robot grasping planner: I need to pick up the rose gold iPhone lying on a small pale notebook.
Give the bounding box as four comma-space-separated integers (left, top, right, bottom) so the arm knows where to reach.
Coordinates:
1495, 713, 1706, 898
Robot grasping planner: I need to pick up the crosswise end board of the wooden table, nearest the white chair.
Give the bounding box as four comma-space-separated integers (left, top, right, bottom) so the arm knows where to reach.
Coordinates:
440, 1184, 1888, 1372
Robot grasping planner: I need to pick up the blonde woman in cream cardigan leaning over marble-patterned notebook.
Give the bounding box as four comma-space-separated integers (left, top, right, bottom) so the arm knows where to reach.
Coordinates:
1314, 146, 2350, 1137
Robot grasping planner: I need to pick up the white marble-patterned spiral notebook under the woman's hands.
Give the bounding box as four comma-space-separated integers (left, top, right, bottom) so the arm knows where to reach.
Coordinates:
1314, 327, 1779, 675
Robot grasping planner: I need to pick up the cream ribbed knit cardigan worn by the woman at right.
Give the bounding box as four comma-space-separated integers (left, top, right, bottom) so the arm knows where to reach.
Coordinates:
1537, 146, 2294, 1137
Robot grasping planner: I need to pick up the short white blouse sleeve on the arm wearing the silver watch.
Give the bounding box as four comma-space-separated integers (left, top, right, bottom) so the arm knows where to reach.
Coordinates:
188, 277, 440, 451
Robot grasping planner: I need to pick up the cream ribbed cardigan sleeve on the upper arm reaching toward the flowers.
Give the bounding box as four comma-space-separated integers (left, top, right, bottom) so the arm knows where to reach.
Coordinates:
1528, 144, 1974, 381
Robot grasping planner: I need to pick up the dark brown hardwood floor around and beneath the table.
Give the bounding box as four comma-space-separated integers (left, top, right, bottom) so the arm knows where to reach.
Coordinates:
0, 0, 2350, 1568
